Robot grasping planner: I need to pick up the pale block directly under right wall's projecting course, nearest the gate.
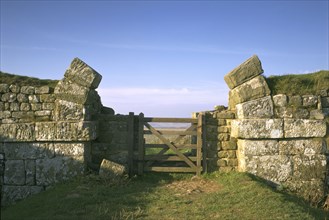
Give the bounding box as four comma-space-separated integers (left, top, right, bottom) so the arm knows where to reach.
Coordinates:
238, 139, 279, 156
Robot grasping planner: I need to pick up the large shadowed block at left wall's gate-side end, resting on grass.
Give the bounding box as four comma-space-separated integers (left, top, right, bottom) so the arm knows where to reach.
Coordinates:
36, 156, 85, 186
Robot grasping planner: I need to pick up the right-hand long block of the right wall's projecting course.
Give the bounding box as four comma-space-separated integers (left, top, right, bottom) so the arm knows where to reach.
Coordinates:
284, 119, 327, 138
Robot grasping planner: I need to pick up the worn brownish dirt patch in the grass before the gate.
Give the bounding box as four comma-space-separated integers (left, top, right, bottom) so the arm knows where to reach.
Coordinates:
165, 176, 222, 196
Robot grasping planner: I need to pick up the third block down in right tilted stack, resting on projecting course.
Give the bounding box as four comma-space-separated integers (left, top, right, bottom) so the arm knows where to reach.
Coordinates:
236, 96, 273, 119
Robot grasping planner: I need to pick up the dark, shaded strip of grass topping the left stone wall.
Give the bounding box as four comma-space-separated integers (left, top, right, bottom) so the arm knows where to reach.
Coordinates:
0, 71, 58, 88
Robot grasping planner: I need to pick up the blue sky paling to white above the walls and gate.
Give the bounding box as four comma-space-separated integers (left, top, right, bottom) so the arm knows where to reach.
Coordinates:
0, 0, 329, 117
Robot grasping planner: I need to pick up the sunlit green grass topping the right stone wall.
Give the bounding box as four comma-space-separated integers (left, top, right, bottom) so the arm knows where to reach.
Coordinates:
266, 70, 329, 95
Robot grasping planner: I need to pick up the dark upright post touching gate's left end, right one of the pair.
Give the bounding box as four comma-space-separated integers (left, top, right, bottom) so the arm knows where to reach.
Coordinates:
138, 113, 145, 175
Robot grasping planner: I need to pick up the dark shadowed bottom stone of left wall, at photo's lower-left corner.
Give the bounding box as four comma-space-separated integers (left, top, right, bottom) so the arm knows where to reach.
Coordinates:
1, 185, 44, 206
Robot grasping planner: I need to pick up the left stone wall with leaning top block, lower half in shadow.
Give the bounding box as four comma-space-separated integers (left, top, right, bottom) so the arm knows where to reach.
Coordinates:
0, 58, 103, 205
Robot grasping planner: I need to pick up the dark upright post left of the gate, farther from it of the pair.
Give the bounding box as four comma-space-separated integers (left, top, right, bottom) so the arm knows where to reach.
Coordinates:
127, 112, 135, 177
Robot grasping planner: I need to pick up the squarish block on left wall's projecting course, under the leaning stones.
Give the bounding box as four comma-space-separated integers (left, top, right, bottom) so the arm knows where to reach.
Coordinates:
54, 100, 85, 121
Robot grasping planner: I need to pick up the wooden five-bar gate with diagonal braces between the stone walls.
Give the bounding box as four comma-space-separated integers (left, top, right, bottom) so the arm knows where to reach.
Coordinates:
130, 113, 206, 175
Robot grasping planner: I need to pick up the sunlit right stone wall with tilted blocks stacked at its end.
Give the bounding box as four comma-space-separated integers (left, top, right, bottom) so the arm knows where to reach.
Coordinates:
219, 56, 329, 203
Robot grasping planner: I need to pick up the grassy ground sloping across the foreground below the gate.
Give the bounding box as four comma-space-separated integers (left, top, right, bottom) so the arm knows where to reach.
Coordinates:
1, 172, 329, 220
